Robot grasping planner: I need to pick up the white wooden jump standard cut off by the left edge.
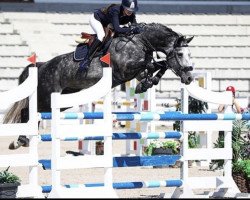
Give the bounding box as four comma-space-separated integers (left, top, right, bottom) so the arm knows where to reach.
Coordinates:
0, 68, 44, 198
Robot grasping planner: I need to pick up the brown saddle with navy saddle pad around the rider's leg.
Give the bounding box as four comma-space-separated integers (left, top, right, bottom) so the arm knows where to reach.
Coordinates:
74, 25, 114, 70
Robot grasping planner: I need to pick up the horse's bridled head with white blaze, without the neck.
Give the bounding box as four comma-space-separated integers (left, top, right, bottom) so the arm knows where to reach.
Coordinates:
167, 36, 193, 85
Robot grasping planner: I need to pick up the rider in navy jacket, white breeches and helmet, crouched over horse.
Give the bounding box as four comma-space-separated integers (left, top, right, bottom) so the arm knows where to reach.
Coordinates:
89, 0, 140, 58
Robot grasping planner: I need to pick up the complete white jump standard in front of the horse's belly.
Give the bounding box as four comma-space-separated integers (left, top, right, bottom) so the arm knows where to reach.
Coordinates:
49, 68, 117, 198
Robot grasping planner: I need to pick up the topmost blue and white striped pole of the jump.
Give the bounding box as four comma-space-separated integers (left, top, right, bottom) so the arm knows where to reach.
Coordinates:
39, 112, 250, 121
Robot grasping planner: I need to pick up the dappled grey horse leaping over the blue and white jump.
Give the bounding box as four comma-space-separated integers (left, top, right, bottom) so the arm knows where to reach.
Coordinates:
3, 23, 193, 149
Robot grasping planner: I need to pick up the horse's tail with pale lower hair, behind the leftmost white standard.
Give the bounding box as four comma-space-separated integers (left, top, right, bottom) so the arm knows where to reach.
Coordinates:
3, 63, 41, 124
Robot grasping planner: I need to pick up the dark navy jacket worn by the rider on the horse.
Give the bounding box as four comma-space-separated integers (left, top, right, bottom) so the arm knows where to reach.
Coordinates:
94, 5, 136, 33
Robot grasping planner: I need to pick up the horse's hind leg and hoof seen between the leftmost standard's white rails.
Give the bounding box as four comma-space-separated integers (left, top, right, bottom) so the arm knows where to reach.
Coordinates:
9, 108, 29, 149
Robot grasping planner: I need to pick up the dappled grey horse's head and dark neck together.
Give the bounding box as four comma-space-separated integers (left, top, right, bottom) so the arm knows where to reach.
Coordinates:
140, 23, 193, 84
